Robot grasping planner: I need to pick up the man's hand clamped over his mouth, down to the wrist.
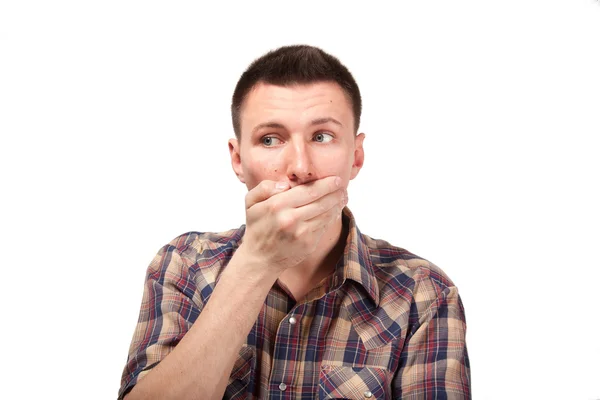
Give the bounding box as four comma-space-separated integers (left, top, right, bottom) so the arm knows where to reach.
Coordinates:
243, 176, 348, 273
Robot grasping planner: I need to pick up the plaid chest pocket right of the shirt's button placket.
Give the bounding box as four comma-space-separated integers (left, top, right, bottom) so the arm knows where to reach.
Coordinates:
319, 365, 391, 400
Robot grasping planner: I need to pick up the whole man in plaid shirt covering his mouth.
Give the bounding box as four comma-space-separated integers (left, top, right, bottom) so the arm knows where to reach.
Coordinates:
119, 46, 470, 400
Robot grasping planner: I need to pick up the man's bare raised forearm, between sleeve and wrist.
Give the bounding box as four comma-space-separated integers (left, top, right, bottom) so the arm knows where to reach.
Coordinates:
126, 245, 277, 400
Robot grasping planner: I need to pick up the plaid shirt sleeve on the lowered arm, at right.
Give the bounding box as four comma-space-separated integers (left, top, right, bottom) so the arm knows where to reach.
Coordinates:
392, 281, 471, 399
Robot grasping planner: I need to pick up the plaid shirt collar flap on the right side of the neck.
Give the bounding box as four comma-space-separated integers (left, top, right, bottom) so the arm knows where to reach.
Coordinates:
334, 207, 379, 307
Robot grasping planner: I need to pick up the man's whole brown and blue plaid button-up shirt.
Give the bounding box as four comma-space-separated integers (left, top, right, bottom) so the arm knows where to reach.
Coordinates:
119, 208, 471, 399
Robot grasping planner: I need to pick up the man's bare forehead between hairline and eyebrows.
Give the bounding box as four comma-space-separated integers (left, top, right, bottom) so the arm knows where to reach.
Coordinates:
240, 82, 353, 131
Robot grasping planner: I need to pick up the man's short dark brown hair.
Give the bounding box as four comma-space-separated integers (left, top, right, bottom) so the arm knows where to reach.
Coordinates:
231, 45, 362, 140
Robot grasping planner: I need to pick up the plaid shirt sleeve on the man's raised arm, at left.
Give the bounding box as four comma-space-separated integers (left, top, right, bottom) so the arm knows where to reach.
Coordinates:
118, 245, 201, 400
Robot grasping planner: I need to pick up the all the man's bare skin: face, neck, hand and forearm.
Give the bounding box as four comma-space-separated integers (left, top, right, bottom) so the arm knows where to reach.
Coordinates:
126, 79, 364, 400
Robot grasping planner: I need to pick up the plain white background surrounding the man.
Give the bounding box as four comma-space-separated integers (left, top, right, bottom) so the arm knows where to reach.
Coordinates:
0, 0, 600, 399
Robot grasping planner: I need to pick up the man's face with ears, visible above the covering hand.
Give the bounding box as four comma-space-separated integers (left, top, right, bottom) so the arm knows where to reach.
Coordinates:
229, 82, 365, 190
